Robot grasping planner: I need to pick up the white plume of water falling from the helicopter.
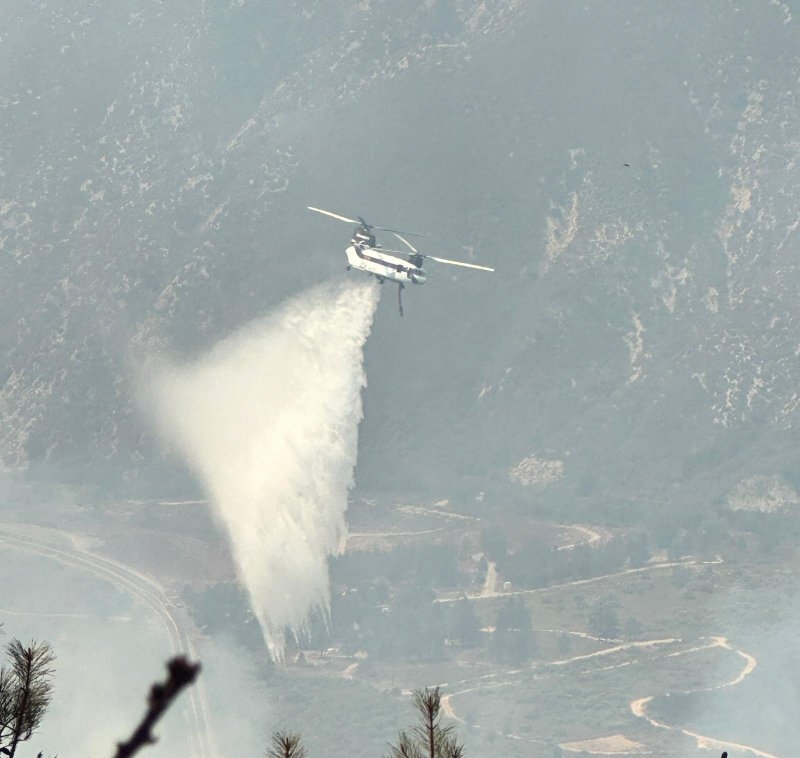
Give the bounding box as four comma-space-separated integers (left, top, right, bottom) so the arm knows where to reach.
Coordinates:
147, 280, 379, 659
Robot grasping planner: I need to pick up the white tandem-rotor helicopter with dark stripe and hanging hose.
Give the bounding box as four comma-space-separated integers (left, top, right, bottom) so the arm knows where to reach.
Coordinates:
306, 205, 494, 316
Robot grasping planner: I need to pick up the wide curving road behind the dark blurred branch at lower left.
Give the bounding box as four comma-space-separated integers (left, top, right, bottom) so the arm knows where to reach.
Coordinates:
0, 525, 218, 758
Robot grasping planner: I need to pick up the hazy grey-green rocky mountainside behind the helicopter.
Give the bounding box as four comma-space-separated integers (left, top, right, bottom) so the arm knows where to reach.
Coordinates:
0, 0, 800, 515
